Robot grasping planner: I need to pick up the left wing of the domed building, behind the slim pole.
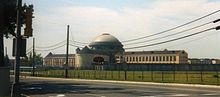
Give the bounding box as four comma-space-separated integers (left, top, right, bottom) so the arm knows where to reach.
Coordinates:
43, 52, 75, 67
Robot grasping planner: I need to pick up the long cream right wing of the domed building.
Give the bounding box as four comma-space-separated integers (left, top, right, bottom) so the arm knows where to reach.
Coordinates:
116, 50, 188, 64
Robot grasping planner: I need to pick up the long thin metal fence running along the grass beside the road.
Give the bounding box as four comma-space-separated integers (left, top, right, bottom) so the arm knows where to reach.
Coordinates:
35, 64, 220, 85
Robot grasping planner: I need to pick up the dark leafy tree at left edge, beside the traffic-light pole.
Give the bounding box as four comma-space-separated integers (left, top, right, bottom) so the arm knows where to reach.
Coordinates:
0, 0, 16, 67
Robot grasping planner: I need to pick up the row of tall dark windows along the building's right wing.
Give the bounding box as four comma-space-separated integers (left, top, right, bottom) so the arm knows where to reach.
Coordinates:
125, 56, 176, 62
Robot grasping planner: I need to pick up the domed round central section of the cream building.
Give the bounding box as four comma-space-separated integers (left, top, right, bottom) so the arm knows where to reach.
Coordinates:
76, 33, 124, 69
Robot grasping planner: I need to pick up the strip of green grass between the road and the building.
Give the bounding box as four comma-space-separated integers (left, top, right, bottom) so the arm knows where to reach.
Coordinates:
31, 70, 220, 85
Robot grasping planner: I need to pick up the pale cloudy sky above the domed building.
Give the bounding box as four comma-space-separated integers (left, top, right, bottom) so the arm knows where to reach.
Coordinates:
5, 0, 220, 59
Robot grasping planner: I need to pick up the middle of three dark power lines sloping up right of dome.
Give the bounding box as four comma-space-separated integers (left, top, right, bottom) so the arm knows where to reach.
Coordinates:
125, 19, 216, 45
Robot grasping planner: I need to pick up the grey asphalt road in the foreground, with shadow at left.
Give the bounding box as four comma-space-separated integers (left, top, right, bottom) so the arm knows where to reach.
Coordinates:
21, 77, 220, 97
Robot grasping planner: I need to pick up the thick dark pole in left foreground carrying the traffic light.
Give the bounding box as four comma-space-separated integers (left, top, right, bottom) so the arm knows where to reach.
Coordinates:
11, 0, 22, 97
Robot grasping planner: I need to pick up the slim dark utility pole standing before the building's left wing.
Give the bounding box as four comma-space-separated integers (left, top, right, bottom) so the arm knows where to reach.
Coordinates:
65, 25, 69, 78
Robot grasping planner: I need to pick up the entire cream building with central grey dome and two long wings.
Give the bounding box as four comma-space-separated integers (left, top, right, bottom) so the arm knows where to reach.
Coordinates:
44, 33, 191, 69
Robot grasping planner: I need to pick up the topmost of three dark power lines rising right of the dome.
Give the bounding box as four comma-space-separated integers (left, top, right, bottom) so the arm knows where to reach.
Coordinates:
122, 10, 220, 42
